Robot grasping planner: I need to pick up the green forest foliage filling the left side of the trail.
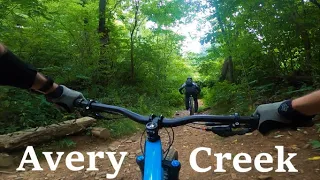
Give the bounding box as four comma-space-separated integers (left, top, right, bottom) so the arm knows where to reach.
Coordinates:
0, 0, 192, 136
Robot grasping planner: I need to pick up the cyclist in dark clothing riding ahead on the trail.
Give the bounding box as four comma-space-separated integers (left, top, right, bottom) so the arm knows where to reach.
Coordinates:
179, 77, 201, 112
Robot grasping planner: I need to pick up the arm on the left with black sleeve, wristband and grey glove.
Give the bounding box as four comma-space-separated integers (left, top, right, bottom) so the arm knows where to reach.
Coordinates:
0, 43, 83, 111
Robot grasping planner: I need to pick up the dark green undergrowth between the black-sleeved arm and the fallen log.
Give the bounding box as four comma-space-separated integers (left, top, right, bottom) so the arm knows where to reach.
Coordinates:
0, 88, 64, 134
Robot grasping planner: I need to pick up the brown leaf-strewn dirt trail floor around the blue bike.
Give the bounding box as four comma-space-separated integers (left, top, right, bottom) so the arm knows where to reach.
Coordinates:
0, 100, 320, 180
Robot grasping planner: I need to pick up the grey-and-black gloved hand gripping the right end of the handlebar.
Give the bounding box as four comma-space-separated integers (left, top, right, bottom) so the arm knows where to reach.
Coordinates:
254, 100, 314, 134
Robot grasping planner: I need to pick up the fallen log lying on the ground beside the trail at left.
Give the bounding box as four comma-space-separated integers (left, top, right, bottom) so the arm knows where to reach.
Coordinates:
0, 117, 96, 151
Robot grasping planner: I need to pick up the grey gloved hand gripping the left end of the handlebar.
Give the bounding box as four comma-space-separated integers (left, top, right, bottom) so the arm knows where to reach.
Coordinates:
46, 85, 85, 112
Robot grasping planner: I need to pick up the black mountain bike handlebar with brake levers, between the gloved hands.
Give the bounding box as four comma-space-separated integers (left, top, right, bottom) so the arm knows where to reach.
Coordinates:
75, 99, 259, 130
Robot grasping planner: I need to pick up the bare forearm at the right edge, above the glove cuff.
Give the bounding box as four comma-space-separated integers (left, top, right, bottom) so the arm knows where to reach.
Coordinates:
292, 90, 320, 115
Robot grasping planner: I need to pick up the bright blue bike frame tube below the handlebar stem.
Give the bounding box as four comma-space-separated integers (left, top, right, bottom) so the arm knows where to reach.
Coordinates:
143, 140, 163, 180
